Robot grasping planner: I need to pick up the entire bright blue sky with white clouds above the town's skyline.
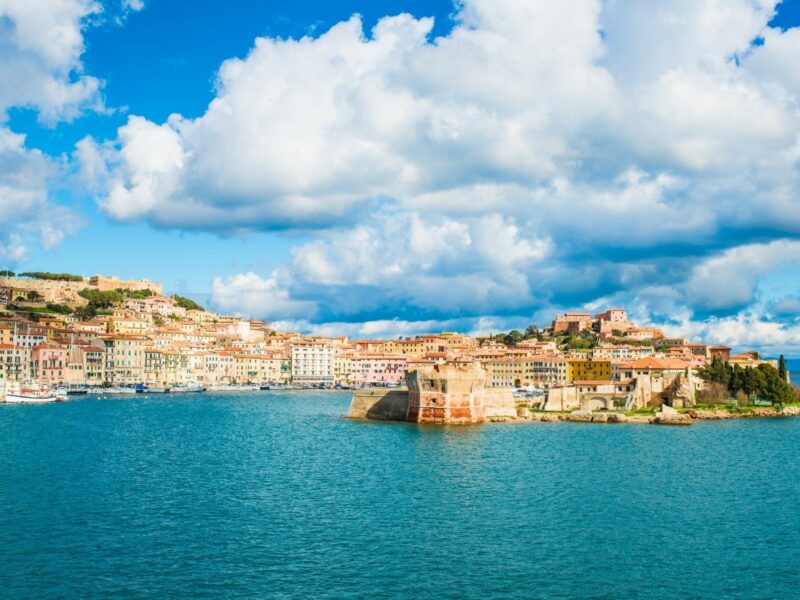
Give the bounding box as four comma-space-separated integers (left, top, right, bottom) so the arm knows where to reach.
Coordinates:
0, 0, 800, 356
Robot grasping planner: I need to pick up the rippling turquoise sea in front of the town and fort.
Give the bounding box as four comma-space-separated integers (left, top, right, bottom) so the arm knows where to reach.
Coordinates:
0, 392, 800, 599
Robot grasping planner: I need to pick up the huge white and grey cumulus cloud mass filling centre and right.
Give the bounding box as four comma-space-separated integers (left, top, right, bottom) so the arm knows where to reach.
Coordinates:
77, 0, 800, 350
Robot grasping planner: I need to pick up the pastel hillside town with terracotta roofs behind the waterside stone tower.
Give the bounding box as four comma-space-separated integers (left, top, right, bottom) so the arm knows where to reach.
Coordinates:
0, 272, 788, 410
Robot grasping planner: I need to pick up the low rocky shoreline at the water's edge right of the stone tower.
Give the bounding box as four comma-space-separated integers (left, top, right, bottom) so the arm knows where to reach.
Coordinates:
487, 406, 800, 426
